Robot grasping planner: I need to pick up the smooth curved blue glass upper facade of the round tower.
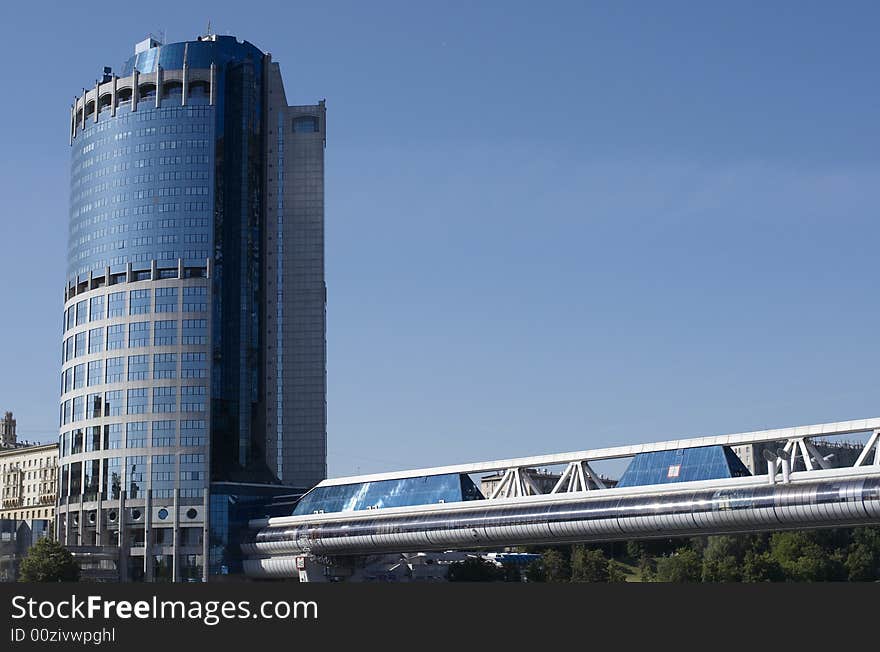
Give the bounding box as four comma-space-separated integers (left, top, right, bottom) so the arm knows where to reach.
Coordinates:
67, 103, 215, 282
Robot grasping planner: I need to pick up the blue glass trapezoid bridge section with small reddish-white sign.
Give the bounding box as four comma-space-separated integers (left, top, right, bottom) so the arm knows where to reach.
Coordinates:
617, 446, 751, 487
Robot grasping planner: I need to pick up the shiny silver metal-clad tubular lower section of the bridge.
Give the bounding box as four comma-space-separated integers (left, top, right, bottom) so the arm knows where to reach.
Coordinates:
243, 477, 880, 575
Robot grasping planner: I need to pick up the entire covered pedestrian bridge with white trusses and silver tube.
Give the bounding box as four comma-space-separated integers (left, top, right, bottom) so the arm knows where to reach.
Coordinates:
242, 418, 880, 577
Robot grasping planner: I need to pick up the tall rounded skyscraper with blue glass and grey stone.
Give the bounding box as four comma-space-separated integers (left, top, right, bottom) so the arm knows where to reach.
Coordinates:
56, 35, 326, 581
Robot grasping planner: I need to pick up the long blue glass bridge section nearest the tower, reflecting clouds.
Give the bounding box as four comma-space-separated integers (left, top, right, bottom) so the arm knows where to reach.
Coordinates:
293, 473, 483, 516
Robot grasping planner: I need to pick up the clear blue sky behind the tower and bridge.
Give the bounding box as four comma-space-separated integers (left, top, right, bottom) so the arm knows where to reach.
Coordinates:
0, 0, 880, 475
